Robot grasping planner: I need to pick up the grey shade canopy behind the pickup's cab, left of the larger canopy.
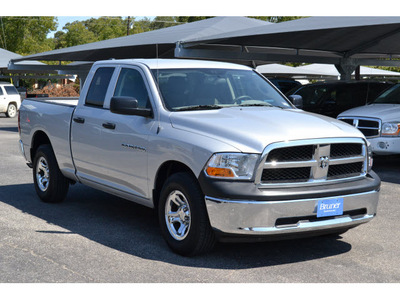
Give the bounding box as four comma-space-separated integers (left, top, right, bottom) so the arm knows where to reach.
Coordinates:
10, 17, 272, 61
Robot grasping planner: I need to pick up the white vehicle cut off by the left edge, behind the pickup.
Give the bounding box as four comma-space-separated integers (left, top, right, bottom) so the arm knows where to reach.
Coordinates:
0, 82, 21, 118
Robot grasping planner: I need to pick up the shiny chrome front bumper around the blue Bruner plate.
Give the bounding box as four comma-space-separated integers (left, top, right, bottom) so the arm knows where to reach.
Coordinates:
205, 191, 379, 236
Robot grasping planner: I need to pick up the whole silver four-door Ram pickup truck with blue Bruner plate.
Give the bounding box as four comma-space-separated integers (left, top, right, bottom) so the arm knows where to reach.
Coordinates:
19, 59, 380, 256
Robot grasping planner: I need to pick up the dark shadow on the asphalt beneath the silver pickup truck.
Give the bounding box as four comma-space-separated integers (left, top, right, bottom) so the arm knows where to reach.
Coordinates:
0, 184, 351, 269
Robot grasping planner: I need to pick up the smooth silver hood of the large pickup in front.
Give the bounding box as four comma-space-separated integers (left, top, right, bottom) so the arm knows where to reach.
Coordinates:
170, 107, 363, 153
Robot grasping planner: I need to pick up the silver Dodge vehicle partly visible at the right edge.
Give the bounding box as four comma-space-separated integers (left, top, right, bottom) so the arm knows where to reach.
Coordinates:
338, 84, 400, 155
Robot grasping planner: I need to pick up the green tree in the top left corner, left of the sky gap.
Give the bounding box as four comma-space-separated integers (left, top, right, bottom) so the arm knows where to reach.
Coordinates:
0, 17, 57, 55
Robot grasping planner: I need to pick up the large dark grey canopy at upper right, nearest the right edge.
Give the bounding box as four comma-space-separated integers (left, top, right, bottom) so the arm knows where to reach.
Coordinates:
176, 17, 400, 79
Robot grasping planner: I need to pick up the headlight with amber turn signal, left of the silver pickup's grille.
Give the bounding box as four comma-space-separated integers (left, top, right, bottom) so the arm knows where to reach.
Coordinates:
204, 153, 260, 180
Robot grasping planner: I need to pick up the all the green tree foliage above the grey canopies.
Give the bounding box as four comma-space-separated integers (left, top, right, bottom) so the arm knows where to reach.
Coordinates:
0, 16, 301, 55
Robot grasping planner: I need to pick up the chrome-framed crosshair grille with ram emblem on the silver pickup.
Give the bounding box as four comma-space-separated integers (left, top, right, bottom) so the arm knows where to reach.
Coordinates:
256, 138, 367, 186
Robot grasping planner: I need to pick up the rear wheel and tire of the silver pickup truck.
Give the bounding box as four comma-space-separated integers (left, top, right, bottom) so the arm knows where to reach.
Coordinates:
32, 145, 69, 203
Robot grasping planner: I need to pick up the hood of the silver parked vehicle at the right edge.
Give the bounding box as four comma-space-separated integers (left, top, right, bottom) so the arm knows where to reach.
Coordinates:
338, 104, 400, 122
